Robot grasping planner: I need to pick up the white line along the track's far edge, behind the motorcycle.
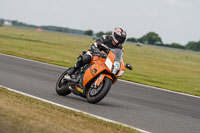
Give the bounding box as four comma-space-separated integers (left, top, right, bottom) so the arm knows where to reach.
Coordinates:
0, 53, 200, 98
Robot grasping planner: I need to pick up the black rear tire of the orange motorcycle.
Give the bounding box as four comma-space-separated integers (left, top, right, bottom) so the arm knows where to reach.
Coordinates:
55, 68, 71, 96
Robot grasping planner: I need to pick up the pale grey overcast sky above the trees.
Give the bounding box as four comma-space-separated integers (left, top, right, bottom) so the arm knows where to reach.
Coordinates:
0, 0, 200, 44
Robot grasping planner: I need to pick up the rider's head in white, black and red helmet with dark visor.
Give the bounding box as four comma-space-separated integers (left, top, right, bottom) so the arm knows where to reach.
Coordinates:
112, 27, 126, 45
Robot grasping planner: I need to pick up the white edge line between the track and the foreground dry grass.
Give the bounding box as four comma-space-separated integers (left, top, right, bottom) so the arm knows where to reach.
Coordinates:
0, 85, 151, 133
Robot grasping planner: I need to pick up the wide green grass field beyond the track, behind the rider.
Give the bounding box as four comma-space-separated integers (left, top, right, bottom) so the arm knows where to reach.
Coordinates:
0, 27, 200, 96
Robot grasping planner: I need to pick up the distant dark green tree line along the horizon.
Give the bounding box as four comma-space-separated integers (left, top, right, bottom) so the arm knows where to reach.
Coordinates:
0, 19, 200, 51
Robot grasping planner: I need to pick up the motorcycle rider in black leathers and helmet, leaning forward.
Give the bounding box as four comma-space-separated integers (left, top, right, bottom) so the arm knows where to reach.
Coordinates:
65, 27, 127, 79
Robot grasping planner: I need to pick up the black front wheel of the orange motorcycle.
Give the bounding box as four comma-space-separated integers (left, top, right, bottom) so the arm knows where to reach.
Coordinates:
86, 77, 112, 104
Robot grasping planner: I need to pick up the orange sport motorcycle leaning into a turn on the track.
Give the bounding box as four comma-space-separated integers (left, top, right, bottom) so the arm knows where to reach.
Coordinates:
56, 49, 132, 104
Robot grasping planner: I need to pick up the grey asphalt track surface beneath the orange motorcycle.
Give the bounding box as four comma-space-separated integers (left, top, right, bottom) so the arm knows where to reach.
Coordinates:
0, 54, 200, 133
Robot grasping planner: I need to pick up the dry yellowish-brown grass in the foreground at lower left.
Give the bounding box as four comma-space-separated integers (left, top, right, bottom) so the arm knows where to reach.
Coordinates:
0, 87, 139, 133
